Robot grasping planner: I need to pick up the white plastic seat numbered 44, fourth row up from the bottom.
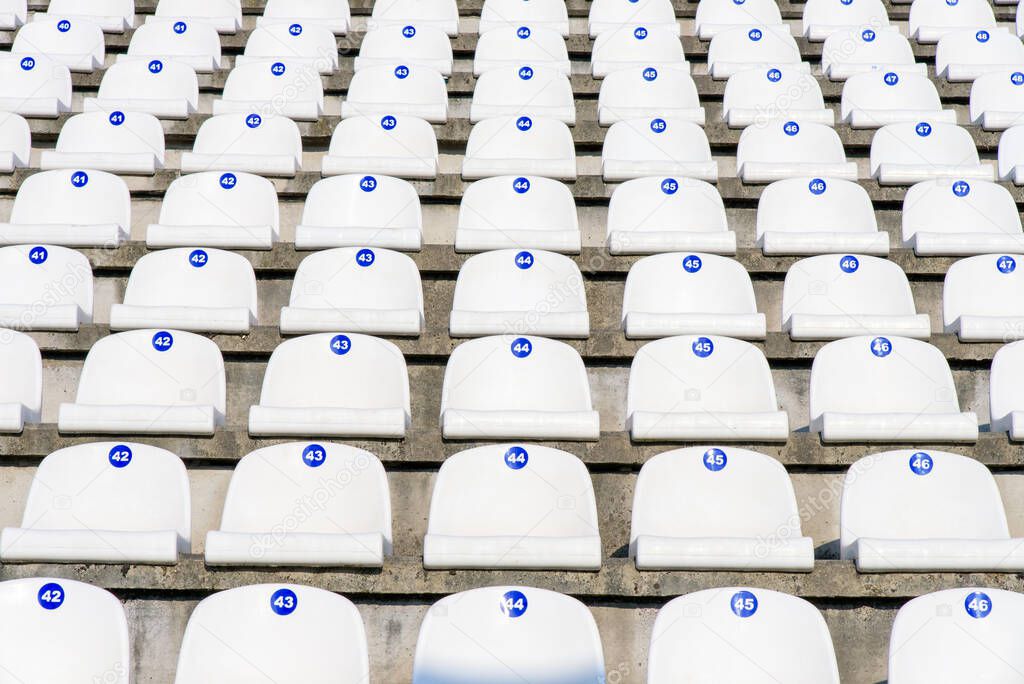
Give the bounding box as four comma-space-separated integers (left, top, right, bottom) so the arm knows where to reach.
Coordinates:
449, 249, 590, 338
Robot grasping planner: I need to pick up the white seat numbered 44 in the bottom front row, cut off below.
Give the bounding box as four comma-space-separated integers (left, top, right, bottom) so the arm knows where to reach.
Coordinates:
413, 587, 604, 684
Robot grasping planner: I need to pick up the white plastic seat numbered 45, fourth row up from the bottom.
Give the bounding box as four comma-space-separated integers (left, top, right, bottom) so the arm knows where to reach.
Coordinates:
622, 252, 766, 340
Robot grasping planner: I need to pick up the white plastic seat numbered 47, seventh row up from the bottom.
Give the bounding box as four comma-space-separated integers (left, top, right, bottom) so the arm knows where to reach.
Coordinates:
840, 72, 956, 128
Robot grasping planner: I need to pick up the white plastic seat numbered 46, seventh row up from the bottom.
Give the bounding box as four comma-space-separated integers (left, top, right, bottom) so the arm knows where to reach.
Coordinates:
720, 68, 835, 128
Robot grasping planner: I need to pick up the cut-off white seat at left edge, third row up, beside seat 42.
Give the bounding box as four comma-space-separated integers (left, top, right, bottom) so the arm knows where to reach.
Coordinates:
0, 329, 43, 432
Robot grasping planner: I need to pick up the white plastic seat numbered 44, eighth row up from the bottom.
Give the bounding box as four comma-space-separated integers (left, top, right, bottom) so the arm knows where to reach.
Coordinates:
473, 26, 569, 76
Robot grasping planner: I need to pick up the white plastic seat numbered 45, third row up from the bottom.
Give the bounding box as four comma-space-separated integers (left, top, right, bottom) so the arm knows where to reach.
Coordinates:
626, 335, 790, 441
